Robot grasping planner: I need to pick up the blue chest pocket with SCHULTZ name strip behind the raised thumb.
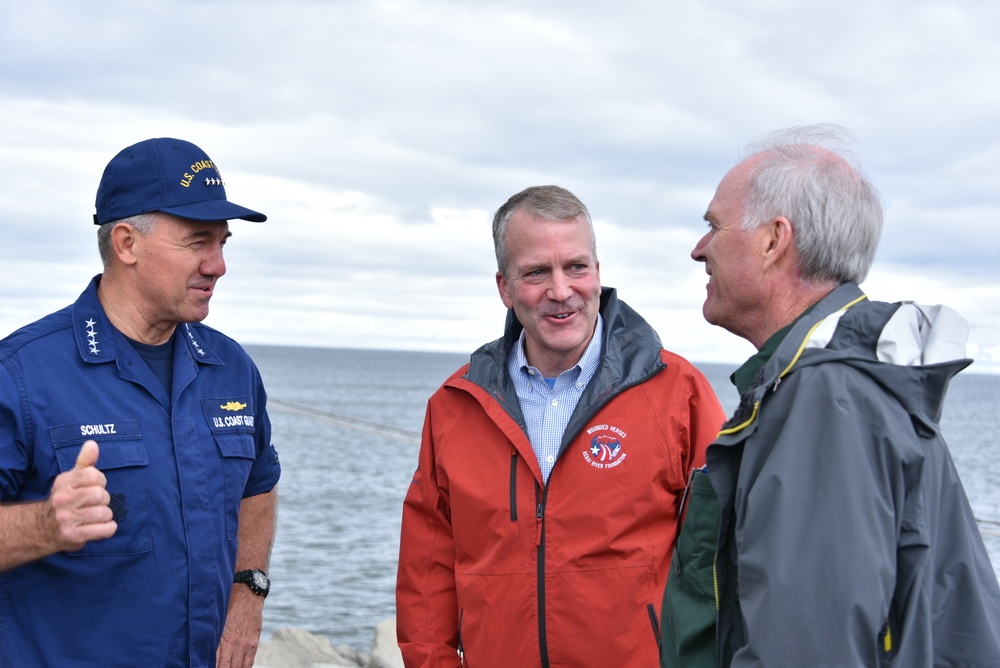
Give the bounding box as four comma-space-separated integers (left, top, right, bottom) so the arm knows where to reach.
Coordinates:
49, 420, 153, 557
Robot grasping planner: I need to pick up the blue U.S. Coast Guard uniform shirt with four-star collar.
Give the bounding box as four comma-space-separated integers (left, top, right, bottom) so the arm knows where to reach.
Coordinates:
0, 276, 281, 668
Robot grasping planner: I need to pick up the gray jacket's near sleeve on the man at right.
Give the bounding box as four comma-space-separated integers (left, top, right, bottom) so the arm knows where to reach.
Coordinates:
732, 364, 904, 668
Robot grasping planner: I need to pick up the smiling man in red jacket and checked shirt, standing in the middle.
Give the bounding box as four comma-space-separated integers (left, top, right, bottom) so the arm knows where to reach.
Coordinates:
396, 186, 725, 668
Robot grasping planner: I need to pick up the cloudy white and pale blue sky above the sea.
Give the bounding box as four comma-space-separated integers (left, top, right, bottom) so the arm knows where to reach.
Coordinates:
0, 0, 1000, 373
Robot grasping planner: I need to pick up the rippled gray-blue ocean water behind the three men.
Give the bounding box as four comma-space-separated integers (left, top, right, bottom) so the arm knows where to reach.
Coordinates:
247, 346, 1000, 651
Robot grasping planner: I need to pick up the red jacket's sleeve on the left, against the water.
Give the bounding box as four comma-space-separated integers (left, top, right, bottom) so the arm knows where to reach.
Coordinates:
396, 398, 461, 668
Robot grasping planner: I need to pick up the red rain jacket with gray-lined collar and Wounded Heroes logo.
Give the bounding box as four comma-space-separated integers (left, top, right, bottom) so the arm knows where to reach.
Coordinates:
396, 289, 725, 668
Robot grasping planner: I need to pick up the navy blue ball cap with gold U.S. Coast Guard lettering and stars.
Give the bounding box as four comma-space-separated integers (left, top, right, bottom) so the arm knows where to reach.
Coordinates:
94, 138, 267, 225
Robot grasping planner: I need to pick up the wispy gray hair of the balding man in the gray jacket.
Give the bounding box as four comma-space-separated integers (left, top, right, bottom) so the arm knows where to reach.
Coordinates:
741, 124, 883, 283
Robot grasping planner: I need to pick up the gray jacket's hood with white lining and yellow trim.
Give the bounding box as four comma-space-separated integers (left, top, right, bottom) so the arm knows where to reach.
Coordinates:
753, 283, 972, 433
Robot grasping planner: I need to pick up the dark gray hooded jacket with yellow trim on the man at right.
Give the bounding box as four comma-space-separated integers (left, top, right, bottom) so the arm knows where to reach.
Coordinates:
707, 283, 1000, 668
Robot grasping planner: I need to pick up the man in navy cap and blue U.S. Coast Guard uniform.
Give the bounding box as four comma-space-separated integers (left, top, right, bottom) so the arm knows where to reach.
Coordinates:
0, 139, 280, 667
